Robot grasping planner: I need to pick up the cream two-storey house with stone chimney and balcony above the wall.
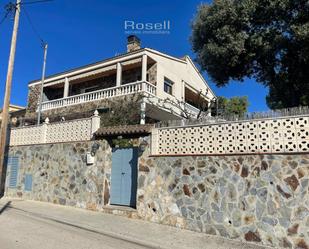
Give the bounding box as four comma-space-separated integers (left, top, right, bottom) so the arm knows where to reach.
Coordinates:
27, 35, 215, 123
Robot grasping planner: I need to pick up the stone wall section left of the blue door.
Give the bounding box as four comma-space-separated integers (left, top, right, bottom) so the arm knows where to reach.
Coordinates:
5, 141, 111, 210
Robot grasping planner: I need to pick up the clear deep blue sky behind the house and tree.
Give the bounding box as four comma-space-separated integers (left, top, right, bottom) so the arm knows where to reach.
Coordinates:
0, 0, 267, 111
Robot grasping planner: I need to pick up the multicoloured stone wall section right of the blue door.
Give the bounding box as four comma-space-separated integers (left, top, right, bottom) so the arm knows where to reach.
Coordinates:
137, 150, 309, 248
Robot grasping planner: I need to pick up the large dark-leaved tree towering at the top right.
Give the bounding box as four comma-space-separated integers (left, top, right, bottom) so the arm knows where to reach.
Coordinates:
191, 0, 309, 109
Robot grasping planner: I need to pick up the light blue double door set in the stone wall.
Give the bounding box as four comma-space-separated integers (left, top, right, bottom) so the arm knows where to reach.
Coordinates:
111, 148, 138, 207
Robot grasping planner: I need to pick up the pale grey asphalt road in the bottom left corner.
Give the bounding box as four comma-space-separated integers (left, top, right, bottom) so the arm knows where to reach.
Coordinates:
0, 207, 153, 249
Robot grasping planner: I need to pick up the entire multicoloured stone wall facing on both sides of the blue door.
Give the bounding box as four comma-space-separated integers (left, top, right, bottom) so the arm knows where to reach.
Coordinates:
6, 140, 309, 249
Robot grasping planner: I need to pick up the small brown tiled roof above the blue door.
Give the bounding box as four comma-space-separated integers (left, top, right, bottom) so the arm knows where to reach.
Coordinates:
95, 124, 154, 137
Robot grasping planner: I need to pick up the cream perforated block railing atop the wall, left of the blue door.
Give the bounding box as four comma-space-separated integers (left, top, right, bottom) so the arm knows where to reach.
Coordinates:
9, 112, 100, 146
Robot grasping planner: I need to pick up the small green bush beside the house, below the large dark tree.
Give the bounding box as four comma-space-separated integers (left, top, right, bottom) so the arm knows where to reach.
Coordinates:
213, 96, 249, 117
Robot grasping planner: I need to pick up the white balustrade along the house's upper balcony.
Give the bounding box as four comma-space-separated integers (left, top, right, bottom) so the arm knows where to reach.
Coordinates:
42, 81, 156, 111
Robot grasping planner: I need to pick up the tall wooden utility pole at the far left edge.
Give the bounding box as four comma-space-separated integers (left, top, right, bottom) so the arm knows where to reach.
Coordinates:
0, 0, 21, 196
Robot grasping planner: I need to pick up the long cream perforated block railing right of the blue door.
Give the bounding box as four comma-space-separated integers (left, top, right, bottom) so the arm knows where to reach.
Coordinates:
151, 115, 309, 155
